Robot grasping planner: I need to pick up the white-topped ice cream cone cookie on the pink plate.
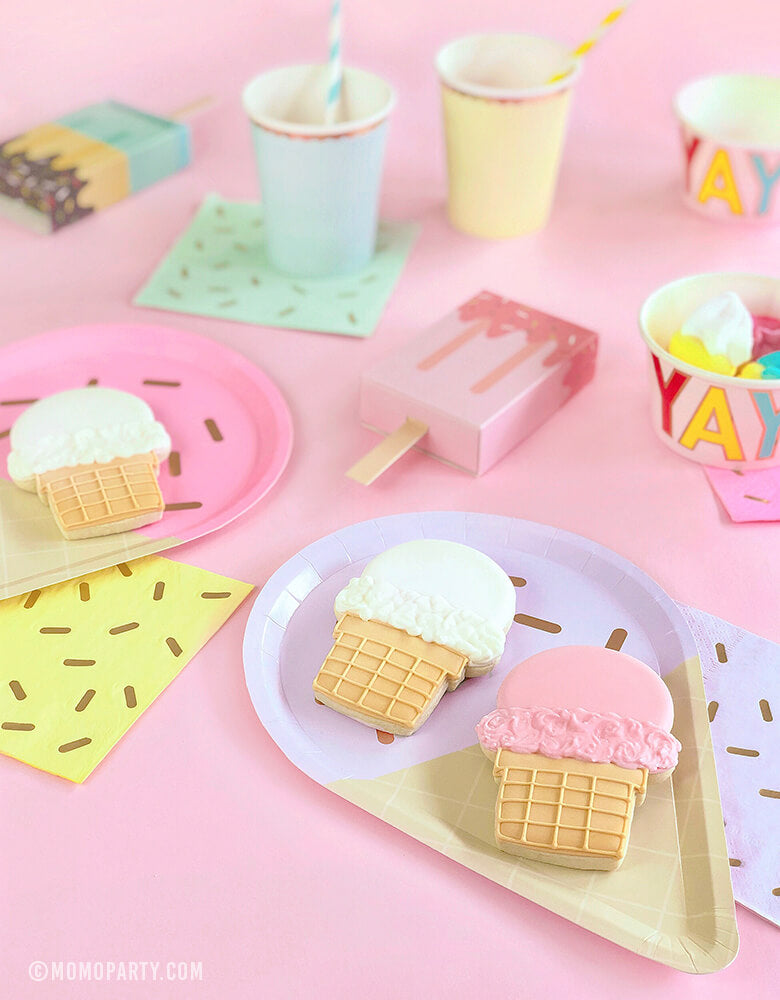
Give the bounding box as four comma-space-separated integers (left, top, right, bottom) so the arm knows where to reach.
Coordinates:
8, 386, 171, 539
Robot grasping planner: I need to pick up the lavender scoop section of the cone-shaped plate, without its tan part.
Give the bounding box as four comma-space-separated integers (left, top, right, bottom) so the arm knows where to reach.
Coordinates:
244, 511, 696, 785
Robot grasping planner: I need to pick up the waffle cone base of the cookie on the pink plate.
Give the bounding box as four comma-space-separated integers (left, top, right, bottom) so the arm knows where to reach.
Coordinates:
36, 452, 165, 539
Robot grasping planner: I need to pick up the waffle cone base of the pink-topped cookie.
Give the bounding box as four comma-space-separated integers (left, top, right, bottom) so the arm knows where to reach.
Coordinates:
493, 749, 647, 871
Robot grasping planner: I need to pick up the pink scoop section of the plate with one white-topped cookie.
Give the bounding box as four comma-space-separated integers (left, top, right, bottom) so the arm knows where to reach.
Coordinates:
0, 323, 293, 596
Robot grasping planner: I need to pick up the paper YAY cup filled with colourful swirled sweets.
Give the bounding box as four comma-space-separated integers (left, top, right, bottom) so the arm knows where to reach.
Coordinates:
639, 274, 780, 470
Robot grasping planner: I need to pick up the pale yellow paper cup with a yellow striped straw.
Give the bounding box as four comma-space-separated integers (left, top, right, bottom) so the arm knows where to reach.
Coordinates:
436, 35, 581, 239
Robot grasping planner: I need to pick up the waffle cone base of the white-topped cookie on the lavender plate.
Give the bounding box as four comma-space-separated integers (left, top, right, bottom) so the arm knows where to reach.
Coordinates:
313, 614, 472, 736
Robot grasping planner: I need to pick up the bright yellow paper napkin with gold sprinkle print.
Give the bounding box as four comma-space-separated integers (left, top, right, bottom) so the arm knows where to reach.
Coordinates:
0, 556, 253, 782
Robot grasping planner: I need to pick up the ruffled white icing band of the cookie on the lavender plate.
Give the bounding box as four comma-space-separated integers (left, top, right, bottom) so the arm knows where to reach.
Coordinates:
335, 575, 506, 666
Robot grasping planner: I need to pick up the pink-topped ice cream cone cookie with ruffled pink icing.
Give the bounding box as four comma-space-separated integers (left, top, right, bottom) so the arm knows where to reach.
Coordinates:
477, 646, 680, 871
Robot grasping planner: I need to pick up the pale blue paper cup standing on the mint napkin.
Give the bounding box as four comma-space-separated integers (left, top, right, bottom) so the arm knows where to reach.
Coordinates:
243, 65, 395, 278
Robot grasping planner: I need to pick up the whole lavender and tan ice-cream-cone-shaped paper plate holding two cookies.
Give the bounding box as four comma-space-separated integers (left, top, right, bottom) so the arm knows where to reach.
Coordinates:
244, 512, 738, 973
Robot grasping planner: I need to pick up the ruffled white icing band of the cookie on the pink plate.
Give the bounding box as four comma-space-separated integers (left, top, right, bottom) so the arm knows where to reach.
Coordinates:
8, 419, 171, 480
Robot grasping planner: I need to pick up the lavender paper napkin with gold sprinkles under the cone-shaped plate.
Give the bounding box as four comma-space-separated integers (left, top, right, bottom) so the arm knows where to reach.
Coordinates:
680, 596, 780, 926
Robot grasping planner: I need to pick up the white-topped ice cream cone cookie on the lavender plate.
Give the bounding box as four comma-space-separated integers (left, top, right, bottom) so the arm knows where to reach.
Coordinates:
313, 539, 515, 736
